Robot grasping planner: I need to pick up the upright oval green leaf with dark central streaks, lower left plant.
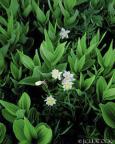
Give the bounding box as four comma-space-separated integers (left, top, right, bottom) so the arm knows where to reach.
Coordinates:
18, 92, 31, 112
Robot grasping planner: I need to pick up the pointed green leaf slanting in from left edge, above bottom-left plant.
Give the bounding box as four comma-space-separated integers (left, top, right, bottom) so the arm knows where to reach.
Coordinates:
0, 100, 19, 116
